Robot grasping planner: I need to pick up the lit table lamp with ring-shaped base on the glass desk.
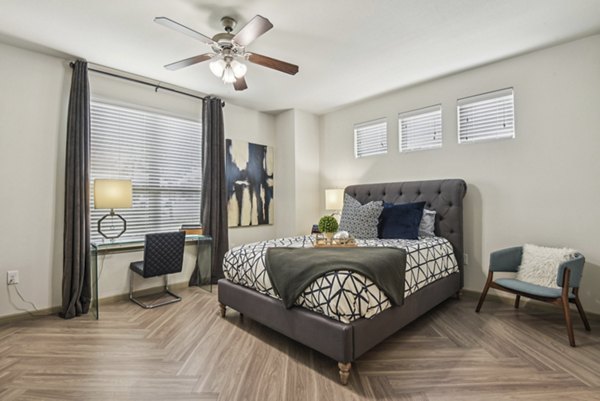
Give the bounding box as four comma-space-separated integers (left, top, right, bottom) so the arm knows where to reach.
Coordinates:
94, 179, 132, 239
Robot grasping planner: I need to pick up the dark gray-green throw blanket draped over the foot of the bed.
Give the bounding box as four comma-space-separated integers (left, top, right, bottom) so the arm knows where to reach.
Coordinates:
266, 247, 406, 308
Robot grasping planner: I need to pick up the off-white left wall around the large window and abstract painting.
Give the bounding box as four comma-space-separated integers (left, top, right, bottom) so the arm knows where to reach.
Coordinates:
0, 43, 278, 316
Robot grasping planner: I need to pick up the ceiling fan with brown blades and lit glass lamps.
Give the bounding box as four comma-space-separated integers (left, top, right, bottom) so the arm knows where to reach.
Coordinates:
154, 15, 298, 91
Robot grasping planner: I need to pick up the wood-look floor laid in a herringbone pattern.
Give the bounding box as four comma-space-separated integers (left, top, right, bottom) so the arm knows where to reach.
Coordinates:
0, 289, 600, 401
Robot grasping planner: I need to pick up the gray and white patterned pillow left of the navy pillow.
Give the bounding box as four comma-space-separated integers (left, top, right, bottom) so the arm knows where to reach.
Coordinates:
340, 194, 383, 239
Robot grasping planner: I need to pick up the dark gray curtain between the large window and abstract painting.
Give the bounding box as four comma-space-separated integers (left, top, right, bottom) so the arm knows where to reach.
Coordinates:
190, 96, 229, 285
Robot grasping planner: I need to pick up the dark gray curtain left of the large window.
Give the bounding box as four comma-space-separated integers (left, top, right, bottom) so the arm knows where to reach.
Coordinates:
60, 60, 91, 319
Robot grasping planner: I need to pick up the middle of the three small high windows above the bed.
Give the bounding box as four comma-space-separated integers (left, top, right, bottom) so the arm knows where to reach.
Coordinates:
398, 104, 442, 152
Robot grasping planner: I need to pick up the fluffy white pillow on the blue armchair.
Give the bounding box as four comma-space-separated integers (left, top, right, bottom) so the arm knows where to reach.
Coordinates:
517, 244, 577, 288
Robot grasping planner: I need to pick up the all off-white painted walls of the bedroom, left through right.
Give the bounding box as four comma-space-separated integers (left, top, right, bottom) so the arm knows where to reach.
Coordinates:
0, 32, 600, 316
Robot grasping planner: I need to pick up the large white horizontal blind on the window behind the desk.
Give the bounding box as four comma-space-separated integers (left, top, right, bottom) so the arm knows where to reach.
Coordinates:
90, 100, 202, 241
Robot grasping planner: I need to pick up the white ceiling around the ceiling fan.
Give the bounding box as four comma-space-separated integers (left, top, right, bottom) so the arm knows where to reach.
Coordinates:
0, 0, 600, 114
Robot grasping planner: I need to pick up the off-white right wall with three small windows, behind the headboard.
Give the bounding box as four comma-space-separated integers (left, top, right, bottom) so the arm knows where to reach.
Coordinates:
320, 35, 600, 313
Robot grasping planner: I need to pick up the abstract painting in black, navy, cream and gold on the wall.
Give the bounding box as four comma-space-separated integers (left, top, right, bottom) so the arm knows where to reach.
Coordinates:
225, 139, 273, 227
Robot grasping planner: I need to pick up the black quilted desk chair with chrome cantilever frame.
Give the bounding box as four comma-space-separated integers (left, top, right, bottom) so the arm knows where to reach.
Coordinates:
129, 231, 185, 309
